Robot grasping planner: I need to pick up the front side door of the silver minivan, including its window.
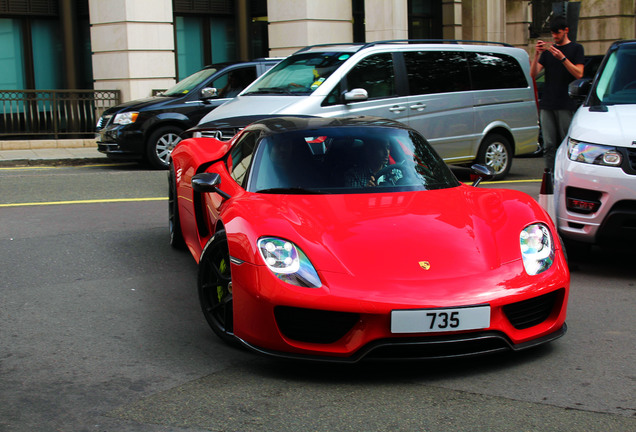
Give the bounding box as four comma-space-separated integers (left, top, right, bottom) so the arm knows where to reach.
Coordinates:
320, 53, 408, 123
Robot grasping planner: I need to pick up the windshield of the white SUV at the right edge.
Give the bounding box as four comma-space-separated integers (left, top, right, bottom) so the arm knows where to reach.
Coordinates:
592, 44, 636, 105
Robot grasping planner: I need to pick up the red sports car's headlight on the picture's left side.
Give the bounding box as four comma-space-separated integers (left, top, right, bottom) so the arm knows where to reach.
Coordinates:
258, 237, 322, 288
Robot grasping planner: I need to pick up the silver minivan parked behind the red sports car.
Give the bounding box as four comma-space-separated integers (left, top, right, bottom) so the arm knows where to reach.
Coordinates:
199, 41, 539, 179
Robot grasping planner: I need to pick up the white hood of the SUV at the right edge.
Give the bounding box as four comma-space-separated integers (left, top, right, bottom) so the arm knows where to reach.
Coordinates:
570, 105, 636, 147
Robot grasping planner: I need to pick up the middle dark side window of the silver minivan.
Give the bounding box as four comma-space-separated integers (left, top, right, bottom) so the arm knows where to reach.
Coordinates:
404, 51, 470, 95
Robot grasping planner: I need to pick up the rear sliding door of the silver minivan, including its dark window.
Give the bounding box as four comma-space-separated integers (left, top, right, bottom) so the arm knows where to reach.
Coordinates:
402, 50, 476, 162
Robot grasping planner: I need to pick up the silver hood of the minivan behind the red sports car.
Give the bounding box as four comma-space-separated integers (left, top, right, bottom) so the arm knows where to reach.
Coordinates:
199, 95, 311, 124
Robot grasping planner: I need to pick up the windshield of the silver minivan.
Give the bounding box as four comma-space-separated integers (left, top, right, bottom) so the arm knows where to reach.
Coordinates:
245, 52, 351, 95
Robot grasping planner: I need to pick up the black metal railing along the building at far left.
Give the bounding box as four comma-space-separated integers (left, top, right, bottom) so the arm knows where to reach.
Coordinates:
0, 90, 121, 139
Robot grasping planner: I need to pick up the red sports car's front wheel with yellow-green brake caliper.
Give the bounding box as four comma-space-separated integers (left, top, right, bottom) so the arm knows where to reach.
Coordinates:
197, 230, 236, 344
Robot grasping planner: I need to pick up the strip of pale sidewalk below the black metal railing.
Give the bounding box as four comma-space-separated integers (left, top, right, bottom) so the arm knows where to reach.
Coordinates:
0, 146, 111, 167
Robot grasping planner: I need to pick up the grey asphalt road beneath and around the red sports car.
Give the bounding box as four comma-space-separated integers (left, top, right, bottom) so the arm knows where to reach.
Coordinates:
0, 159, 636, 432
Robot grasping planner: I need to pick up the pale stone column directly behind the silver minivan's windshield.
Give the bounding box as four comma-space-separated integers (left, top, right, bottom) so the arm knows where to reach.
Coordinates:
267, 0, 352, 57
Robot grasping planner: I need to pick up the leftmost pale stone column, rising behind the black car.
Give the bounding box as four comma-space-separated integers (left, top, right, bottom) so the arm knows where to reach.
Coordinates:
89, 0, 176, 101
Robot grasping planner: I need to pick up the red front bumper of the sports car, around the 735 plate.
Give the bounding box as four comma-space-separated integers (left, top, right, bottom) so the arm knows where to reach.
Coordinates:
232, 252, 569, 363
